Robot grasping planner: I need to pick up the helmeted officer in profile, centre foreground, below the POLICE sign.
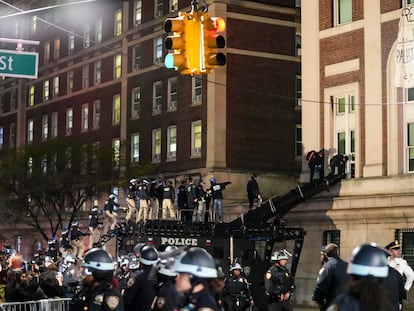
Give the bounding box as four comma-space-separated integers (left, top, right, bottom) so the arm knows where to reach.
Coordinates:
174, 247, 220, 311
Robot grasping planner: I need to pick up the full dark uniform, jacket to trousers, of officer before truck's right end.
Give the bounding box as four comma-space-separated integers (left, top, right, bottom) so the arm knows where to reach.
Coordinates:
265, 265, 295, 311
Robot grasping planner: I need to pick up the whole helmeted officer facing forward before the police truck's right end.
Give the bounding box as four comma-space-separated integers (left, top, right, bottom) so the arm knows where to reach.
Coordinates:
264, 249, 295, 311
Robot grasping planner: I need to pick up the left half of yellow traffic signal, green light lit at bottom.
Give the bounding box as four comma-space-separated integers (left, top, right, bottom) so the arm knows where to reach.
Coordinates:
164, 12, 202, 75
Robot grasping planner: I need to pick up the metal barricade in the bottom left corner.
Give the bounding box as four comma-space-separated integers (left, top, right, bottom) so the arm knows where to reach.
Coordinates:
0, 298, 72, 311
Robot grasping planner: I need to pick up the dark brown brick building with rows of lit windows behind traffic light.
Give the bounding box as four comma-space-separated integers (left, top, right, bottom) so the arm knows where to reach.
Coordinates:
0, 0, 302, 260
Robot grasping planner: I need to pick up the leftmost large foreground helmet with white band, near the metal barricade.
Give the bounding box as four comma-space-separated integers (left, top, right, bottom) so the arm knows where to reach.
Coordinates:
82, 248, 115, 280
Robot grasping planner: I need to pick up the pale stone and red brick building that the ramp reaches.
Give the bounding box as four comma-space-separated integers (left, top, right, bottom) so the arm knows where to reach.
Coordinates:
292, 0, 414, 306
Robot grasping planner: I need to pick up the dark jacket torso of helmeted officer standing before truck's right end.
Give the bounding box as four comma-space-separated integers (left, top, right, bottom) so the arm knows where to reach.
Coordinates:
265, 265, 295, 296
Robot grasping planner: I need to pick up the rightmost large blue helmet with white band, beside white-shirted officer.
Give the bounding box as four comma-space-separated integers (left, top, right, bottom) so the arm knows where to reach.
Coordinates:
347, 244, 388, 278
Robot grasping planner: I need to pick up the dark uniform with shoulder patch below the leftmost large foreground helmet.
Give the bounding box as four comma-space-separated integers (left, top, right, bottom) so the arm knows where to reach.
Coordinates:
70, 281, 124, 311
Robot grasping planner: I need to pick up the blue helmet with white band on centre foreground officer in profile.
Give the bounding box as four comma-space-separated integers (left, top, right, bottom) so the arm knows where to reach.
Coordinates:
174, 247, 217, 279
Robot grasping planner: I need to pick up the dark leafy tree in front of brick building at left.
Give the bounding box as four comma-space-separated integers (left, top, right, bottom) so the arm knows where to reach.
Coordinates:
0, 140, 119, 241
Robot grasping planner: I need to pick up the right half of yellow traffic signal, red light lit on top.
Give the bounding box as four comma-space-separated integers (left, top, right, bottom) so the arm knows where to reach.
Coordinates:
202, 13, 226, 73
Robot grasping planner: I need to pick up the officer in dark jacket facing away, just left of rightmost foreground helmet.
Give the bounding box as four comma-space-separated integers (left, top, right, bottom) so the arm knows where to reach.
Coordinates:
312, 243, 351, 311
